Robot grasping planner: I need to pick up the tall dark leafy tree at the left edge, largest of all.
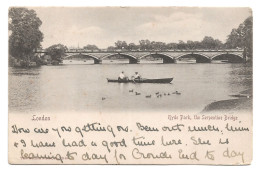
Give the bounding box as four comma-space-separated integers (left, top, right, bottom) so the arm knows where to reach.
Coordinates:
9, 7, 43, 66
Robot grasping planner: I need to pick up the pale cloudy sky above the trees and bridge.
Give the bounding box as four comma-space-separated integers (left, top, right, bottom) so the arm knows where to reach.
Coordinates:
30, 7, 252, 48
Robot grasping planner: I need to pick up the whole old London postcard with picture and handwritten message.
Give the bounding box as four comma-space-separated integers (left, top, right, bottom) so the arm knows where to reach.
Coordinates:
8, 6, 253, 165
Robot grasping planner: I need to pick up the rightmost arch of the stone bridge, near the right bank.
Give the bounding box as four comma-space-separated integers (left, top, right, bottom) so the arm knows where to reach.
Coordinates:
212, 53, 244, 63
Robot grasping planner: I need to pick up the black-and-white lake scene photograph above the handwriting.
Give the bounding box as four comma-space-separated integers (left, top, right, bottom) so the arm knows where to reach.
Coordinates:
8, 7, 253, 113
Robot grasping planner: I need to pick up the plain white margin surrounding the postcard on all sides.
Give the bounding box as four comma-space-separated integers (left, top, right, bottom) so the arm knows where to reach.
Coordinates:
0, 0, 260, 171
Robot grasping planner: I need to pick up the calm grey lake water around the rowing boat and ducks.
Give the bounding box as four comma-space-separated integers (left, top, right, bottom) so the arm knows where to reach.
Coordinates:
9, 61, 252, 112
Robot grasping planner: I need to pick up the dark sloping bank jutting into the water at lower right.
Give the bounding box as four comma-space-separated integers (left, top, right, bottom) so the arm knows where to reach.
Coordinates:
200, 89, 253, 113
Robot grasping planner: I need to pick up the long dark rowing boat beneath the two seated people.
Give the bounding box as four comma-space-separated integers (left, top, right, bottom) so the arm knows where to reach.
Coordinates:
107, 78, 173, 84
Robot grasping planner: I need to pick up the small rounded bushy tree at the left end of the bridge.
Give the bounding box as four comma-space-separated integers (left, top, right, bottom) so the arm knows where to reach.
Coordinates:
46, 44, 68, 62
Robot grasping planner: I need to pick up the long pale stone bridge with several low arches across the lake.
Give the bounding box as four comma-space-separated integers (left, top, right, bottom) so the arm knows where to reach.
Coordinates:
37, 50, 245, 64
